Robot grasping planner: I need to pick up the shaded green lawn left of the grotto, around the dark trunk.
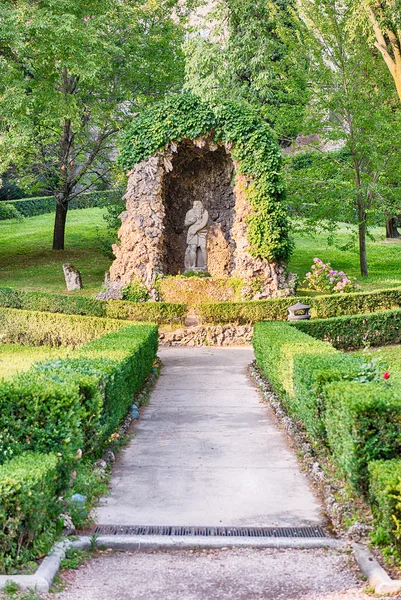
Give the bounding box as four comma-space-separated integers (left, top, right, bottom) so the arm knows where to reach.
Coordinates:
0, 208, 112, 295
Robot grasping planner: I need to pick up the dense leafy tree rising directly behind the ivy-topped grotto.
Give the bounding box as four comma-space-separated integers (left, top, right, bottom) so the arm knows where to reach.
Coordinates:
185, 0, 308, 143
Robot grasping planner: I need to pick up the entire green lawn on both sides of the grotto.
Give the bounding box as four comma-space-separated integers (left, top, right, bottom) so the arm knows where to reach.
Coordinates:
0, 208, 401, 295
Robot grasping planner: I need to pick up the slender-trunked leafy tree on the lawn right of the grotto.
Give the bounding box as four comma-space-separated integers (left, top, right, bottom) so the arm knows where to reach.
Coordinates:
301, 0, 401, 275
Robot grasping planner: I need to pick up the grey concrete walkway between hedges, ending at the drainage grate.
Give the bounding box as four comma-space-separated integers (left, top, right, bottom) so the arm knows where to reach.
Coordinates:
95, 347, 323, 526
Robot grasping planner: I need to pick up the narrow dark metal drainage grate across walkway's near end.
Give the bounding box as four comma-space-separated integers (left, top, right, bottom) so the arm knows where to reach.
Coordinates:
90, 525, 328, 538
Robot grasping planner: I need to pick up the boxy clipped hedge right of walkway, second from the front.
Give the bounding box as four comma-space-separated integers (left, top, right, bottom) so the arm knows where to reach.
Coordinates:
324, 381, 401, 491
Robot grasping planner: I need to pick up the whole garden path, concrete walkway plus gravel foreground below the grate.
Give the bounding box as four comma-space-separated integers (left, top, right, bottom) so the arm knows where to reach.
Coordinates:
50, 348, 376, 600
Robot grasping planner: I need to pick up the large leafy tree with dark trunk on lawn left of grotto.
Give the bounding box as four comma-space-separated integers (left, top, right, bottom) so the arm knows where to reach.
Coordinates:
0, 0, 183, 250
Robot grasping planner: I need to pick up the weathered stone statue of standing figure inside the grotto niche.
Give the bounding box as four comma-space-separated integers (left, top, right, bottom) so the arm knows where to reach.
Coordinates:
185, 200, 209, 271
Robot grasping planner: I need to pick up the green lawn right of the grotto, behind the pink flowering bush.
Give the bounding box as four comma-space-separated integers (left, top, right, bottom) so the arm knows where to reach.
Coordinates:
289, 227, 401, 291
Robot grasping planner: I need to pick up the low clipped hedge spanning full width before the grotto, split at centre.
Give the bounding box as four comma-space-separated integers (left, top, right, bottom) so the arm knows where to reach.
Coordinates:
0, 287, 401, 328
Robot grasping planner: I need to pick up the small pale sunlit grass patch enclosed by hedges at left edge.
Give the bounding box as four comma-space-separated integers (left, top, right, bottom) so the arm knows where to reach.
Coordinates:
0, 344, 71, 379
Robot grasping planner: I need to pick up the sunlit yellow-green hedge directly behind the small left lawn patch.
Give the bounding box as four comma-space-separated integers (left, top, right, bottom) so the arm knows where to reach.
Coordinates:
0, 308, 126, 348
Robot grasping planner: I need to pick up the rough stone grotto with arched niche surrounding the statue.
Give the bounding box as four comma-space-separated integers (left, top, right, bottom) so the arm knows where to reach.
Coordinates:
110, 136, 295, 299
